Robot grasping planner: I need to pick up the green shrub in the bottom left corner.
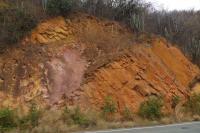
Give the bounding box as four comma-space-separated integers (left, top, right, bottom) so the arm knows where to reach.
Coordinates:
0, 108, 16, 131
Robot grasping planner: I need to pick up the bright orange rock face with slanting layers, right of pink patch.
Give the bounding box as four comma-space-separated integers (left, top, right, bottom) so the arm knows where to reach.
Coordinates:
80, 39, 199, 111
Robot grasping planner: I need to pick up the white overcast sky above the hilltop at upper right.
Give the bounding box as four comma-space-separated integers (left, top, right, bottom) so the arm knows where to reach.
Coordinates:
146, 0, 200, 10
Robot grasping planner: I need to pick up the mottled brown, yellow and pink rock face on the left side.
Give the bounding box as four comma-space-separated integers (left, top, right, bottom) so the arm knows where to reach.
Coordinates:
0, 45, 87, 107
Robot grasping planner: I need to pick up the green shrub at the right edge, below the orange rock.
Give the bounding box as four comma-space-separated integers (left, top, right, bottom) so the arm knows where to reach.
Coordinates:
186, 94, 200, 115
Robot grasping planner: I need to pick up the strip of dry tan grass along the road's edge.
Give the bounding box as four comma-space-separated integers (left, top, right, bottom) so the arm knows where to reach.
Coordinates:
4, 108, 200, 133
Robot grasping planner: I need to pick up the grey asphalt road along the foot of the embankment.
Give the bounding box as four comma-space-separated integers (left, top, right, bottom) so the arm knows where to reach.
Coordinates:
84, 122, 200, 133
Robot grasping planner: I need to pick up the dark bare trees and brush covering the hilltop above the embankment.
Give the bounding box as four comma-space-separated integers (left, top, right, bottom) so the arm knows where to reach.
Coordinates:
0, 0, 200, 65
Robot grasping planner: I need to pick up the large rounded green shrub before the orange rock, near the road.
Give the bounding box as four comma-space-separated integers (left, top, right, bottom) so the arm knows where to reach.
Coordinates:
139, 97, 162, 120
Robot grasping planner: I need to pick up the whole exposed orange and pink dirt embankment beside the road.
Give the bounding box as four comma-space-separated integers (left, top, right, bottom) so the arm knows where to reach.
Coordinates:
0, 14, 200, 111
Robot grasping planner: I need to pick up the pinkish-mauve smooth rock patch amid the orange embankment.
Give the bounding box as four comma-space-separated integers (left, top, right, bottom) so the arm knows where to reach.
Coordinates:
46, 50, 86, 104
